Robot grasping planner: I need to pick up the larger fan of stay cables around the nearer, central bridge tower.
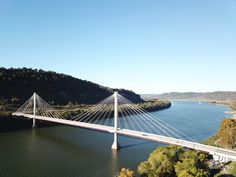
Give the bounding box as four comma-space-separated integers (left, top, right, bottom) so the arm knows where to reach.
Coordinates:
71, 94, 194, 141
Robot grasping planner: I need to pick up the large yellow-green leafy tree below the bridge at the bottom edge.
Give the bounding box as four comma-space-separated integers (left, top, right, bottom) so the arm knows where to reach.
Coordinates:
138, 146, 210, 177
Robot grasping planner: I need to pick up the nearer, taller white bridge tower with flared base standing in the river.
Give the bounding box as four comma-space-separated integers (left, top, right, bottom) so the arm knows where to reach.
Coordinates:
111, 92, 120, 150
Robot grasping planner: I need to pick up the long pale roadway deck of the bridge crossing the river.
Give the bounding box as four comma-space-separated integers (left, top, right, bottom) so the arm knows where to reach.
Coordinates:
12, 113, 236, 161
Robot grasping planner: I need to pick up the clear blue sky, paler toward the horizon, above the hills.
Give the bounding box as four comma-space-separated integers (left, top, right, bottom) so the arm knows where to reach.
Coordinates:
0, 0, 236, 93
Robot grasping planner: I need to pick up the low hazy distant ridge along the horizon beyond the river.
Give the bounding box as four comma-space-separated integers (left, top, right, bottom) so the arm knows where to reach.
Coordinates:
141, 91, 236, 101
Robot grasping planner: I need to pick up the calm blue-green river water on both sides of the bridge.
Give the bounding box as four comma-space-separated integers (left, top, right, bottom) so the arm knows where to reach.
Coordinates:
0, 101, 229, 177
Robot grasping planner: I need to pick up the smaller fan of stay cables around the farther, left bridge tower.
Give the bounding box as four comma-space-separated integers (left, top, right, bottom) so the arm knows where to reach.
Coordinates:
16, 93, 64, 119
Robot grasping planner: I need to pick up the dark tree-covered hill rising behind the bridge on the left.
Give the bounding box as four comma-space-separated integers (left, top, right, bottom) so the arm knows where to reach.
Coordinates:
0, 68, 143, 105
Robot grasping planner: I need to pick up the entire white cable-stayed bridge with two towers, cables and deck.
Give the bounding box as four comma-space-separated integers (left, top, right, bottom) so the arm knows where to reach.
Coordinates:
13, 92, 236, 162
